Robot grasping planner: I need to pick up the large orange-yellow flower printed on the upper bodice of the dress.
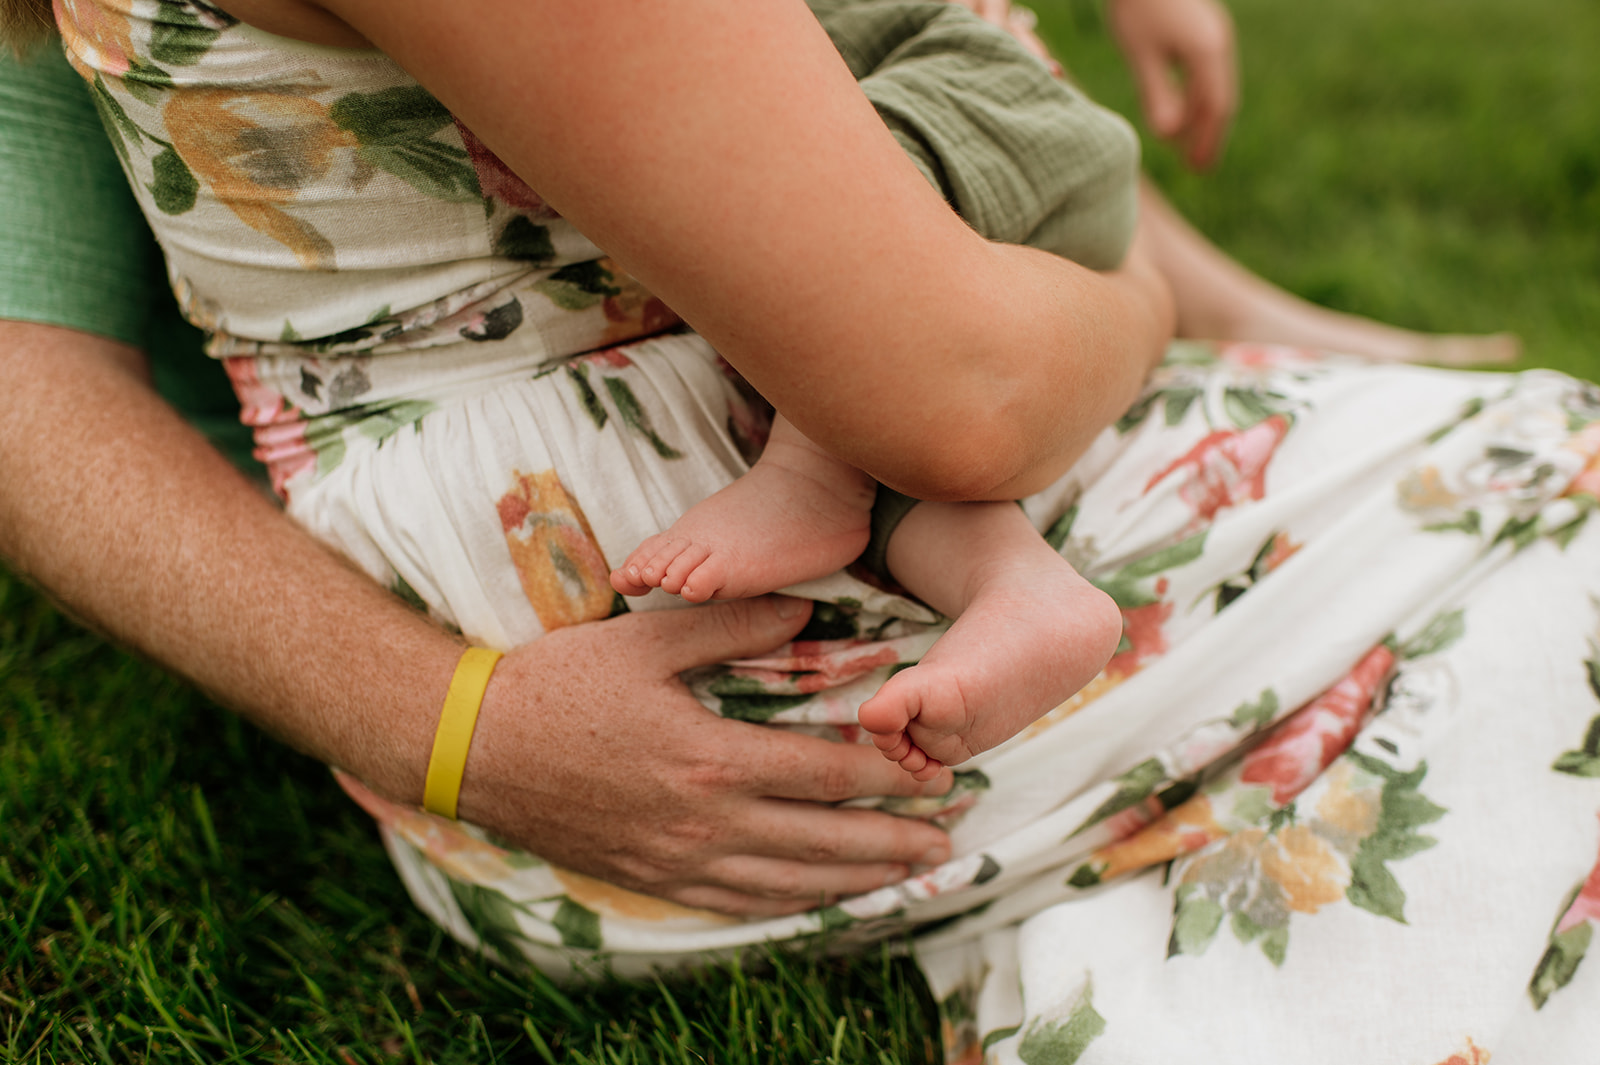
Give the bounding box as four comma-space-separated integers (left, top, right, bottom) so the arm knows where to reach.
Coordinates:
162, 90, 357, 270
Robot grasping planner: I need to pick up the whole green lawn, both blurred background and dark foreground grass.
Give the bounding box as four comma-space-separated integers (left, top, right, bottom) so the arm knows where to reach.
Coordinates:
0, 0, 1600, 1065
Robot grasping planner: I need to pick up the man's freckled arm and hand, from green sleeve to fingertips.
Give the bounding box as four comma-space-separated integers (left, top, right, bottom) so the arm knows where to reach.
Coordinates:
0, 321, 949, 913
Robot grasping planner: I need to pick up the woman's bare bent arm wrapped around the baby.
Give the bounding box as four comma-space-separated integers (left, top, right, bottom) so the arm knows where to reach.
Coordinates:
300, 0, 1170, 499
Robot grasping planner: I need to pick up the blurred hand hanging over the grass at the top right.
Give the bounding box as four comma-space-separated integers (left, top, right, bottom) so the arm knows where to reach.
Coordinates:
1109, 0, 1238, 170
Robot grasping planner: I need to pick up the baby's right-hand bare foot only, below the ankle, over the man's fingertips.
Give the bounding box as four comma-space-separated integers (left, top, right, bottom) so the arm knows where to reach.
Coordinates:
861, 548, 1122, 780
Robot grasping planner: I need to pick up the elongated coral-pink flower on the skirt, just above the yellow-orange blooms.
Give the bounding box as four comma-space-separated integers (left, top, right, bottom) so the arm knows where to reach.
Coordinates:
1238, 644, 1395, 806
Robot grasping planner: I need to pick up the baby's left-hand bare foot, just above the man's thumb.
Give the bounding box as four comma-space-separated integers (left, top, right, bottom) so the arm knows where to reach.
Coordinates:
611, 416, 877, 603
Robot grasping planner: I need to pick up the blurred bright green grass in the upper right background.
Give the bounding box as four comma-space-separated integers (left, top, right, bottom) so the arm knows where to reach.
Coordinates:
1040, 0, 1600, 379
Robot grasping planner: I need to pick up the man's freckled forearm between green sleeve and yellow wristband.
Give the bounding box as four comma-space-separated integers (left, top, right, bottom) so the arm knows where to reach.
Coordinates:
0, 321, 459, 801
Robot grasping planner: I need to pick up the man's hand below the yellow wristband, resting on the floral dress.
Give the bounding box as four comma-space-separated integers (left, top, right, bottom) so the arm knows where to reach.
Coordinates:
459, 596, 950, 916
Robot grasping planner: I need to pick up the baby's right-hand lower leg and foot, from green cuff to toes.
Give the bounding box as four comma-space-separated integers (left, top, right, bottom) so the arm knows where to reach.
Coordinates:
861, 502, 1122, 780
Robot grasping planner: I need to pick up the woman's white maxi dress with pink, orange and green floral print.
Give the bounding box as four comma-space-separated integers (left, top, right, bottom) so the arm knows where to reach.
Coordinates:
58, 0, 1600, 1065
